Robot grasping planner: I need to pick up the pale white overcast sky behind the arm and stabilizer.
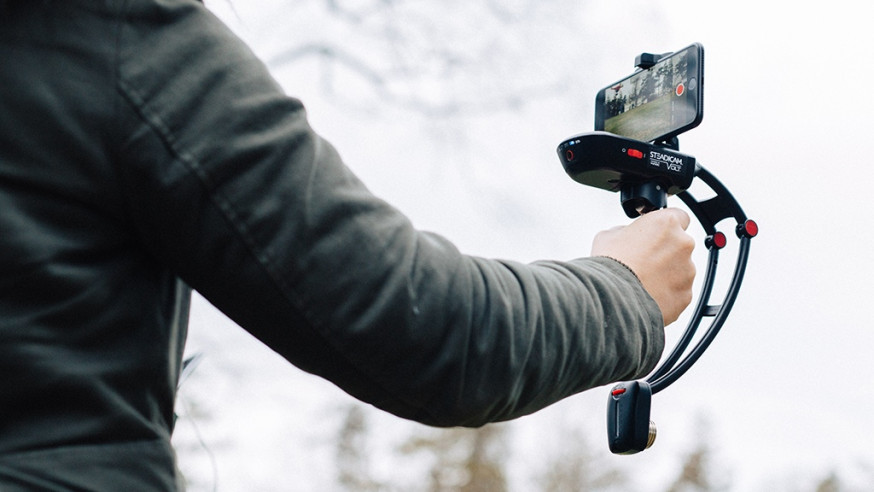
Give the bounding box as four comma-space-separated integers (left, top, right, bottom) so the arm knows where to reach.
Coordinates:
180, 0, 874, 490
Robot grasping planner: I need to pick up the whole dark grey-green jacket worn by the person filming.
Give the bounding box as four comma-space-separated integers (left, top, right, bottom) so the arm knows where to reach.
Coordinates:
0, 0, 664, 491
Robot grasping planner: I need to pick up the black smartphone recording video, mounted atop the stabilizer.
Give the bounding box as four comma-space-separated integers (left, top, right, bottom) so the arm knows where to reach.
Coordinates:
595, 43, 704, 142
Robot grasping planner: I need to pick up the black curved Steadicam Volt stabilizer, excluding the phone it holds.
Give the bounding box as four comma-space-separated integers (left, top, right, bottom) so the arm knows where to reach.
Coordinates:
557, 54, 759, 454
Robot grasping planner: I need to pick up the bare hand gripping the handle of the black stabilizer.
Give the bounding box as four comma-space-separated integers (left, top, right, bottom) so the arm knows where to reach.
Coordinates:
592, 208, 695, 326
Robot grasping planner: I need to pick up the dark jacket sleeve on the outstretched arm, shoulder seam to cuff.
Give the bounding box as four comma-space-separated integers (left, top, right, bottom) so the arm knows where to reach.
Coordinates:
113, 2, 664, 426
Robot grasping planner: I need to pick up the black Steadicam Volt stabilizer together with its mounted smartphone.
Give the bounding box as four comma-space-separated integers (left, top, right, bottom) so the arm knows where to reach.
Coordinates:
557, 44, 759, 454
